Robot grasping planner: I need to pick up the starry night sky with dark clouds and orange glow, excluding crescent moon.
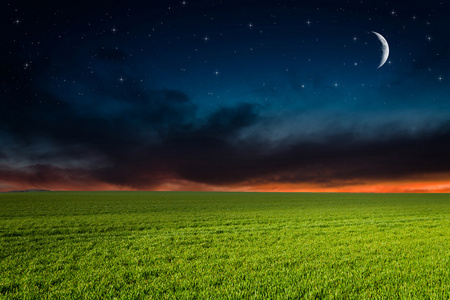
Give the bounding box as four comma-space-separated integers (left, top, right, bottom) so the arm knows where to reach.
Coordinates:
0, 0, 450, 192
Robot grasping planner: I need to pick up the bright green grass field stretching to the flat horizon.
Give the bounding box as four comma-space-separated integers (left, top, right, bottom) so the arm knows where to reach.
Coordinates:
0, 192, 450, 299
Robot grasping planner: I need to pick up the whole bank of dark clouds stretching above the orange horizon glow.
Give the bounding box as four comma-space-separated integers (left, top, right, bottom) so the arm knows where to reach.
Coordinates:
0, 71, 450, 189
